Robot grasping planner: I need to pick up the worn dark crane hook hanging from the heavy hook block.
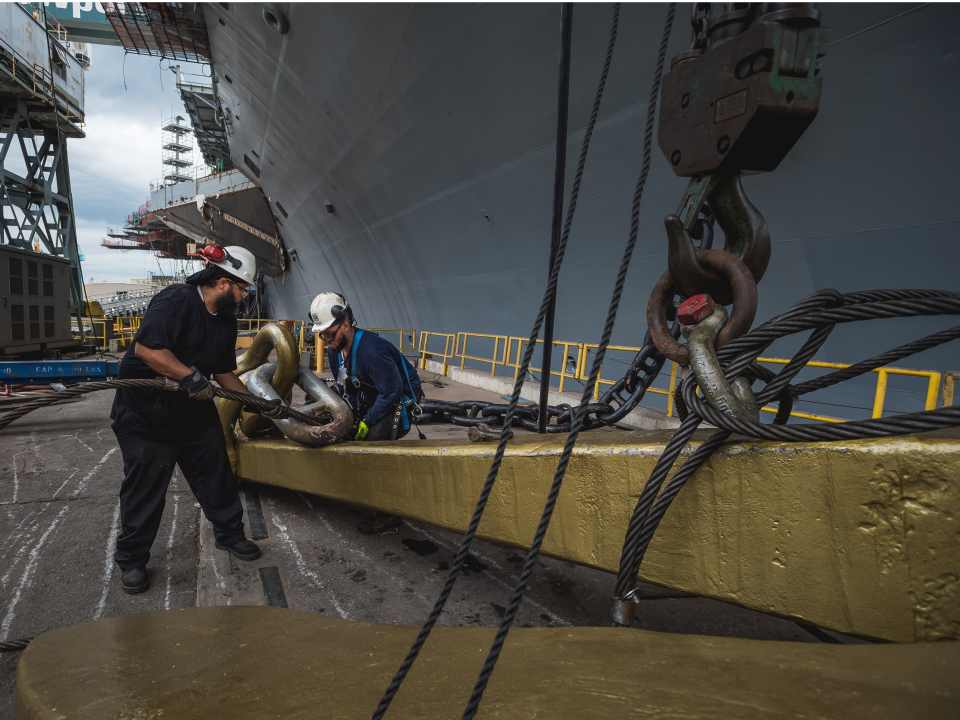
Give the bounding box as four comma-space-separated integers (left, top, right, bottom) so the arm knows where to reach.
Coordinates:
663, 173, 770, 305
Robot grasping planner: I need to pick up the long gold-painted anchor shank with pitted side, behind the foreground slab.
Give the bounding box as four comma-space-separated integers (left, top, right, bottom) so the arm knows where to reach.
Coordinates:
238, 431, 960, 642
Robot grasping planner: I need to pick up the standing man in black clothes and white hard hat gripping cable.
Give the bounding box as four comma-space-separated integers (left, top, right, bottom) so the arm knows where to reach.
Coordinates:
110, 246, 260, 593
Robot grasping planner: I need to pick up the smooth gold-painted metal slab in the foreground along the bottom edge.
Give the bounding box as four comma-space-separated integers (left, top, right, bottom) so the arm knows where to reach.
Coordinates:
17, 607, 960, 720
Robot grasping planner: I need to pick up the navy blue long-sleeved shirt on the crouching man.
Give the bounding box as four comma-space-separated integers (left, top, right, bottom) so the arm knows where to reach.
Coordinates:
327, 330, 420, 427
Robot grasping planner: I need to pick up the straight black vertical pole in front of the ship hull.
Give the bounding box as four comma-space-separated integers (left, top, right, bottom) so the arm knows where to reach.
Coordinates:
539, 2, 573, 433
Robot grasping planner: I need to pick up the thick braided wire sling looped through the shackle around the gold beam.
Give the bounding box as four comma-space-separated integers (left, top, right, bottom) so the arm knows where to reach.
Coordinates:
616, 290, 960, 597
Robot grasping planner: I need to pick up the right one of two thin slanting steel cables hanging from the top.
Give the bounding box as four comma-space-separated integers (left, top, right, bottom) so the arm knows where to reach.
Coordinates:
463, 3, 676, 720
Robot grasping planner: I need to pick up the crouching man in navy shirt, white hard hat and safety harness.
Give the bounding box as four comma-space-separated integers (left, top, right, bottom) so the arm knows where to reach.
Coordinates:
310, 293, 424, 533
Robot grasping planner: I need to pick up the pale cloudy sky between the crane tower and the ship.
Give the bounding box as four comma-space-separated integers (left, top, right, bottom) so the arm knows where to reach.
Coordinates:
67, 45, 209, 283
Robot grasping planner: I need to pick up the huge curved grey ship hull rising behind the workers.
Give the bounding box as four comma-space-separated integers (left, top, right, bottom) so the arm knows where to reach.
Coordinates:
204, 3, 960, 417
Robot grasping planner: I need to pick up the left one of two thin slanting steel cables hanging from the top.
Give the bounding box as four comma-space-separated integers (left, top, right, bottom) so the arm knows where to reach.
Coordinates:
373, 3, 632, 720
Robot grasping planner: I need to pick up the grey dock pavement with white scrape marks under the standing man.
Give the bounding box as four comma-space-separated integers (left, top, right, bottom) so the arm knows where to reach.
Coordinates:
0, 362, 860, 719
